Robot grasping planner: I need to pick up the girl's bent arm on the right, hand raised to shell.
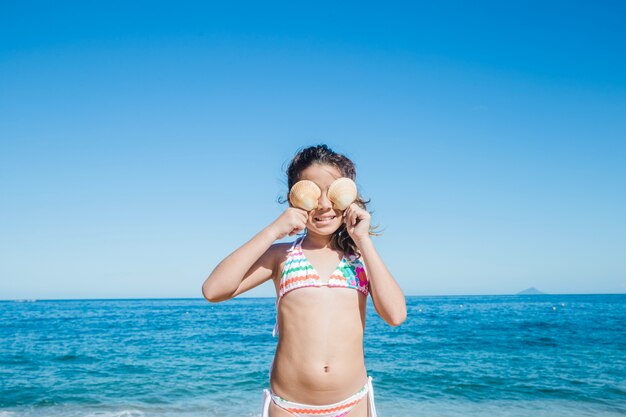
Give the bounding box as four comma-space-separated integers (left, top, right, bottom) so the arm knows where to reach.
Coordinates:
344, 204, 406, 326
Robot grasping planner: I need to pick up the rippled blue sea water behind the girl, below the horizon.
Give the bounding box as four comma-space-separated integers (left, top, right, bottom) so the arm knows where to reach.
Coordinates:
0, 294, 626, 417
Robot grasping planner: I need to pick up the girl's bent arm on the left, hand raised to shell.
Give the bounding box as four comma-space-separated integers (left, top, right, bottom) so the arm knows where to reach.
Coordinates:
202, 207, 308, 303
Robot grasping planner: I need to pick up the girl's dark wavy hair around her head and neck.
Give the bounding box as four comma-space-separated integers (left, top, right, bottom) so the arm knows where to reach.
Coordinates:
278, 145, 378, 258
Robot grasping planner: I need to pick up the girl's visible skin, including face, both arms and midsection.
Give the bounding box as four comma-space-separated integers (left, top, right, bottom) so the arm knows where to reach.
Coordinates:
202, 164, 406, 417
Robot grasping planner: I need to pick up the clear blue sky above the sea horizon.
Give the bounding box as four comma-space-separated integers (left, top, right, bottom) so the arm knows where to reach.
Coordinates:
0, 1, 626, 299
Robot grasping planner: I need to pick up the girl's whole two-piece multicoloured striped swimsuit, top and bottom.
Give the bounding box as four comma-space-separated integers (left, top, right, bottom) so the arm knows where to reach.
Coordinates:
262, 234, 376, 417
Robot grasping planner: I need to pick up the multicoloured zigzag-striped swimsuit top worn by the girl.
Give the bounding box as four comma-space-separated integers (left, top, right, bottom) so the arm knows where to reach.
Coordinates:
272, 234, 369, 336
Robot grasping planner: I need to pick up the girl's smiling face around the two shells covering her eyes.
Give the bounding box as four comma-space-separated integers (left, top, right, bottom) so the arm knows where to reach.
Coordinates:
298, 164, 343, 235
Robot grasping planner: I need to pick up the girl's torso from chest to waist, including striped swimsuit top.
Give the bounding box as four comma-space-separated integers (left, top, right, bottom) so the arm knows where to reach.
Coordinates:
270, 237, 369, 404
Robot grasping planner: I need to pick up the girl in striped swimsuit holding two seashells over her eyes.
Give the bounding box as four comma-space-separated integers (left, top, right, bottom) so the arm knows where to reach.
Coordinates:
202, 145, 406, 417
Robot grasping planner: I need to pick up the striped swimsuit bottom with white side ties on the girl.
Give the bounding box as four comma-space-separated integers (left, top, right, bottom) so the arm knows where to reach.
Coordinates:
261, 376, 377, 417
